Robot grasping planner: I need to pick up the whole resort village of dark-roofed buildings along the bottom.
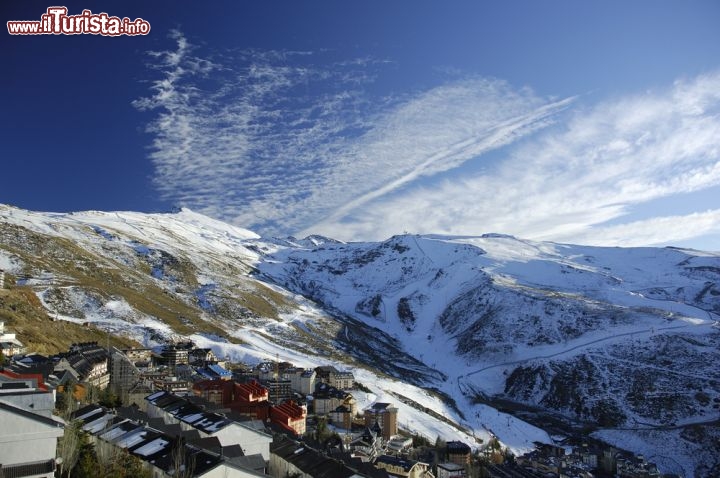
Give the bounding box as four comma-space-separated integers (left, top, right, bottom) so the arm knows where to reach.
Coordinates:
0, 322, 670, 478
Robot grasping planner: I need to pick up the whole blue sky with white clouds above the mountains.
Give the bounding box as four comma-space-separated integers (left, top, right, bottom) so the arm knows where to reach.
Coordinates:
0, 0, 720, 250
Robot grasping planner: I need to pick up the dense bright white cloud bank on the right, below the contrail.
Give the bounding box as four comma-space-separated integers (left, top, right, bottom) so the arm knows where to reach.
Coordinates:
310, 73, 720, 250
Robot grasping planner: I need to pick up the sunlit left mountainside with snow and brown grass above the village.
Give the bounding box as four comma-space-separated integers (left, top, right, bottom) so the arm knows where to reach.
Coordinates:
0, 205, 549, 460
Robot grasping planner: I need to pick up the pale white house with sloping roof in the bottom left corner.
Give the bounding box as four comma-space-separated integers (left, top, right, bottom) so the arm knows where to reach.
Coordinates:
0, 399, 65, 478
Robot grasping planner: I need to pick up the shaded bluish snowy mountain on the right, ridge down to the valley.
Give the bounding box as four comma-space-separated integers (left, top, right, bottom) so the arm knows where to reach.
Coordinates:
259, 234, 720, 474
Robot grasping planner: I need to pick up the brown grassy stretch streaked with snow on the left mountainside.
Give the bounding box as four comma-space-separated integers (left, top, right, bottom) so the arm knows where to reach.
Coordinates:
0, 224, 292, 342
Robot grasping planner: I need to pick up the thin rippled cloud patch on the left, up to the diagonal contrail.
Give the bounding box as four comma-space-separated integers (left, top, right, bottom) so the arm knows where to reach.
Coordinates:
135, 32, 571, 234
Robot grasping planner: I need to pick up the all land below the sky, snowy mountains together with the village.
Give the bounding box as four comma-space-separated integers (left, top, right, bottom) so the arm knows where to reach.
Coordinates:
0, 206, 720, 478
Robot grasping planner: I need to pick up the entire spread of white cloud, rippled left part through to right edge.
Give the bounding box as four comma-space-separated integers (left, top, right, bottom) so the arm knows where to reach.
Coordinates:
135, 32, 720, 245
